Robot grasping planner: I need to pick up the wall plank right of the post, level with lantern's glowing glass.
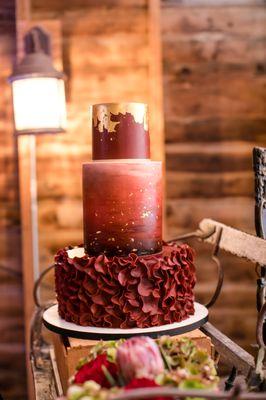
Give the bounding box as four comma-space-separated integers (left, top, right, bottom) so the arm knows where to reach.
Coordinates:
164, 71, 266, 118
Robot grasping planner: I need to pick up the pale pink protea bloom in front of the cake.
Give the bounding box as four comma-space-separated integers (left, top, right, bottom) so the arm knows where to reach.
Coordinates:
116, 336, 164, 383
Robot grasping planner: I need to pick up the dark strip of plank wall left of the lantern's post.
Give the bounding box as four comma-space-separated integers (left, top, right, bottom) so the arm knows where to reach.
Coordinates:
0, 0, 26, 400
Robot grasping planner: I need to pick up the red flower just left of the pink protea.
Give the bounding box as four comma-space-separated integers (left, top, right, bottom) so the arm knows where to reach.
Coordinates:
74, 354, 117, 388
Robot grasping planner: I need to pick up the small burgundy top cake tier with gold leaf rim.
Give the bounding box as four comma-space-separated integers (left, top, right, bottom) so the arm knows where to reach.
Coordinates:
92, 103, 150, 160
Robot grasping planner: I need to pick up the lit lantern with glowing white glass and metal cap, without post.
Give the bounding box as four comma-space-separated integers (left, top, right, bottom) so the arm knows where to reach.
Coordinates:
9, 27, 66, 134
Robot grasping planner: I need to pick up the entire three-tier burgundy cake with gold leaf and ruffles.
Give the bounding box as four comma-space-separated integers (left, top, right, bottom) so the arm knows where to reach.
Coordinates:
55, 103, 195, 328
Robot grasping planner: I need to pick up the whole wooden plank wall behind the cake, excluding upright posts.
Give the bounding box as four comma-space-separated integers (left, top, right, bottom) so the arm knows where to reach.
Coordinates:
0, 0, 266, 400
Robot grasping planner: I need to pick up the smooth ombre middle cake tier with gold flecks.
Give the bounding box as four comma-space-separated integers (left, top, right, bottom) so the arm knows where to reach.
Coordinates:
83, 160, 162, 256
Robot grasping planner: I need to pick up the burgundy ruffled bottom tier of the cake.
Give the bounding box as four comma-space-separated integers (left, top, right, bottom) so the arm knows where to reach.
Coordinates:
55, 244, 196, 328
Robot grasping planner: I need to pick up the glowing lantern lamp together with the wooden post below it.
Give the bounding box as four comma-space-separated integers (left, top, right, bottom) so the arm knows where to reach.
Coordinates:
8, 27, 66, 284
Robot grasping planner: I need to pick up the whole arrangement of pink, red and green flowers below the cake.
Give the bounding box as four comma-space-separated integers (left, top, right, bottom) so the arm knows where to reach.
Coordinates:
64, 336, 218, 400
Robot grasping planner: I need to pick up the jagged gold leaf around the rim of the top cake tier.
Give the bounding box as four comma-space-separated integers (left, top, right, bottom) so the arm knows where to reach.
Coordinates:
92, 103, 148, 133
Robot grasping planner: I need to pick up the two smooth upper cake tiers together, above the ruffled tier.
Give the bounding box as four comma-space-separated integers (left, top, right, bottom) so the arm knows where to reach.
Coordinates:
83, 103, 162, 256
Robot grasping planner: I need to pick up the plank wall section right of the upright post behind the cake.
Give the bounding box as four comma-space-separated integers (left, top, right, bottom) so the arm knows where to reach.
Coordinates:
162, 0, 266, 351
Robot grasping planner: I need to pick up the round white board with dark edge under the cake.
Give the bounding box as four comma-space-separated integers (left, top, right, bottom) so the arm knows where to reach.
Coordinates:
43, 303, 208, 340
